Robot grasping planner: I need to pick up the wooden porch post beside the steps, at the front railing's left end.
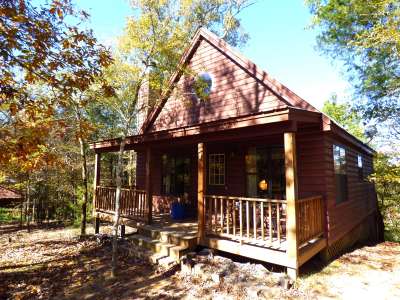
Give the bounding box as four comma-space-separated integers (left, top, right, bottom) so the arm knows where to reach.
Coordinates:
197, 143, 207, 242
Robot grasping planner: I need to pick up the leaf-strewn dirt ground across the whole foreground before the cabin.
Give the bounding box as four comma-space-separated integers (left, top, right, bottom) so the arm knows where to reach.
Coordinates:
0, 224, 400, 299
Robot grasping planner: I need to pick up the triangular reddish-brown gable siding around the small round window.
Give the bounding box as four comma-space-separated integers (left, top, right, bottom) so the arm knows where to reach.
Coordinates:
150, 40, 286, 131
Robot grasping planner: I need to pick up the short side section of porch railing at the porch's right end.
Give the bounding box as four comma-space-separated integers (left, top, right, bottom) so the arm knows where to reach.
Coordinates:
296, 196, 324, 246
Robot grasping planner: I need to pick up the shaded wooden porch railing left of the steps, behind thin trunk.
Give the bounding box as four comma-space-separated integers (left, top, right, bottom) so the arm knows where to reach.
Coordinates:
95, 186, 148, 219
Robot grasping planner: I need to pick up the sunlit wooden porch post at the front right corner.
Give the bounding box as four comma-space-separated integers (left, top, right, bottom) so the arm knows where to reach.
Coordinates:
284, 132, 299, 280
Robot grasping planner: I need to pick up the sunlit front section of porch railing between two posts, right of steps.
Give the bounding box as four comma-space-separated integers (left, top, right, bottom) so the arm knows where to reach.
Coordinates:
204, 195, 286, 248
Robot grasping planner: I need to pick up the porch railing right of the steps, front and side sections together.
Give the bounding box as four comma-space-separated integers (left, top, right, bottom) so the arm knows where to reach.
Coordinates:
204, 195, 324, 249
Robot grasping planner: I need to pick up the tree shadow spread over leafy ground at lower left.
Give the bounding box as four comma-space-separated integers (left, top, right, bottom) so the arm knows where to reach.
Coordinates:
0, 226, 188, 299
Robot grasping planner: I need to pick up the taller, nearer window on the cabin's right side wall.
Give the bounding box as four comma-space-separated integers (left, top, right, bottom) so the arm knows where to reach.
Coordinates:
333, 145, 347, 203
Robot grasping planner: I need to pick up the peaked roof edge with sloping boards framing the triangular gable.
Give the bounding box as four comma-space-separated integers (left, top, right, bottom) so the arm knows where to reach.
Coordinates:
140, 28, 320, 134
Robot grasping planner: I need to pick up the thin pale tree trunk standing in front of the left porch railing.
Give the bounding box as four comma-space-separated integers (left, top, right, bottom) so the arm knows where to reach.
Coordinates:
111, 132, 128, 277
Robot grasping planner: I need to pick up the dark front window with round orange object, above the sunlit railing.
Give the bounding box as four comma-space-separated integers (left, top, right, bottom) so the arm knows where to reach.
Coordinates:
245, 147, 286, 199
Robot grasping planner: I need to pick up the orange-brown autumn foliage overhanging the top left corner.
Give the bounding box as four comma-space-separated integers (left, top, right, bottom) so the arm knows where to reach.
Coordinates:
0, 0, 111, 167
